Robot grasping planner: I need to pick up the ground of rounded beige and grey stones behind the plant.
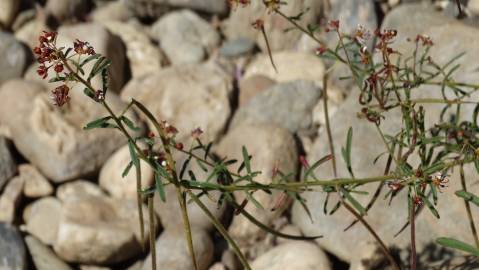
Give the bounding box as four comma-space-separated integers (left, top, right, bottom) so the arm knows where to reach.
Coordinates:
0, 0, 479, 270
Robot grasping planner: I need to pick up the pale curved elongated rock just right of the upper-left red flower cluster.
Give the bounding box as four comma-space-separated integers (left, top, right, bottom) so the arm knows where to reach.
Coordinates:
103, 21, 164, 78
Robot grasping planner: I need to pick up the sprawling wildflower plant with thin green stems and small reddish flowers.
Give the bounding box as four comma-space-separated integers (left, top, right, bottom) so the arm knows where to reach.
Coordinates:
34, 0, 479, 269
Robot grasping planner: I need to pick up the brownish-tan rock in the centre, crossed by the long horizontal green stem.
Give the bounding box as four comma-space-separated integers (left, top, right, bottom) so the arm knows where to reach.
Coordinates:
214, 124, 298, 246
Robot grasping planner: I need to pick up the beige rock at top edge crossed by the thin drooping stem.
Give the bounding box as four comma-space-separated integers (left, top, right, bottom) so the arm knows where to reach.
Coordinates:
223, 0, 323, 52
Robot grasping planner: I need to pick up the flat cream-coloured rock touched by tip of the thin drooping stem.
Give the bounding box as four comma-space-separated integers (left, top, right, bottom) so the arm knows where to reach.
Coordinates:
244, 52, 325, 90
